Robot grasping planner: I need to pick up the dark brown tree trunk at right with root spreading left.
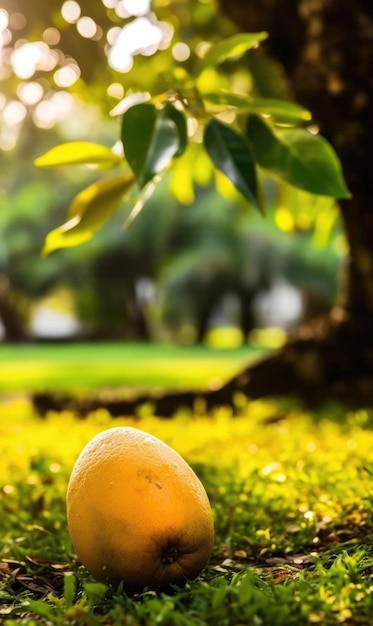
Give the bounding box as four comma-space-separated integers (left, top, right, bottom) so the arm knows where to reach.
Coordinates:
32, 0, 373, 415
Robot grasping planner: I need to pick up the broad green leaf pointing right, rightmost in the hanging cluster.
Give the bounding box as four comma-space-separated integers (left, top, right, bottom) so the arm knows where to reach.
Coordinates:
247, 116, 351, 198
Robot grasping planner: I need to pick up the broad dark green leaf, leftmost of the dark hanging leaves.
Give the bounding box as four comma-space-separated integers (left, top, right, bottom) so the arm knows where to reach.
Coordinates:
122, 104, 181, 189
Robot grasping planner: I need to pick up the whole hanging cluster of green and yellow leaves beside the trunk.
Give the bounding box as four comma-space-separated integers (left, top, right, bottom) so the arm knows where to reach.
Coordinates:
36, 33, 349, 254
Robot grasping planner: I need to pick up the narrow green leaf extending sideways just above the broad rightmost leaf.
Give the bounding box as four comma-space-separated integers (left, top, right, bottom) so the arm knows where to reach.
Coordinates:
203, 91, 311, 124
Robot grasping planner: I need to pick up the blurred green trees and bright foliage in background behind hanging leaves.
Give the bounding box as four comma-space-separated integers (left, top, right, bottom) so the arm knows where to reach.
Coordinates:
0, 0, 345, 382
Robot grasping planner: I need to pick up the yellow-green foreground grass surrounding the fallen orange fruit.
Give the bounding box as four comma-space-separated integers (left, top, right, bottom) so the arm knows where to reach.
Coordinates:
0, 398, 373, 626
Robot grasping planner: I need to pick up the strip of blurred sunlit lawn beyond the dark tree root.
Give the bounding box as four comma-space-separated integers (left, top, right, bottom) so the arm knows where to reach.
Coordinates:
0, 343, 263, 393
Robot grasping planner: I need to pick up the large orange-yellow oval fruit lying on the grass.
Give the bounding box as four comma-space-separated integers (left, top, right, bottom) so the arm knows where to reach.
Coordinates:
66, 426, 214, 593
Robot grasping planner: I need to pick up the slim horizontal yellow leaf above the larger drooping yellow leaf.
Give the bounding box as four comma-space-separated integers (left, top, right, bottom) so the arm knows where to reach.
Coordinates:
35, 141, 123, 167
